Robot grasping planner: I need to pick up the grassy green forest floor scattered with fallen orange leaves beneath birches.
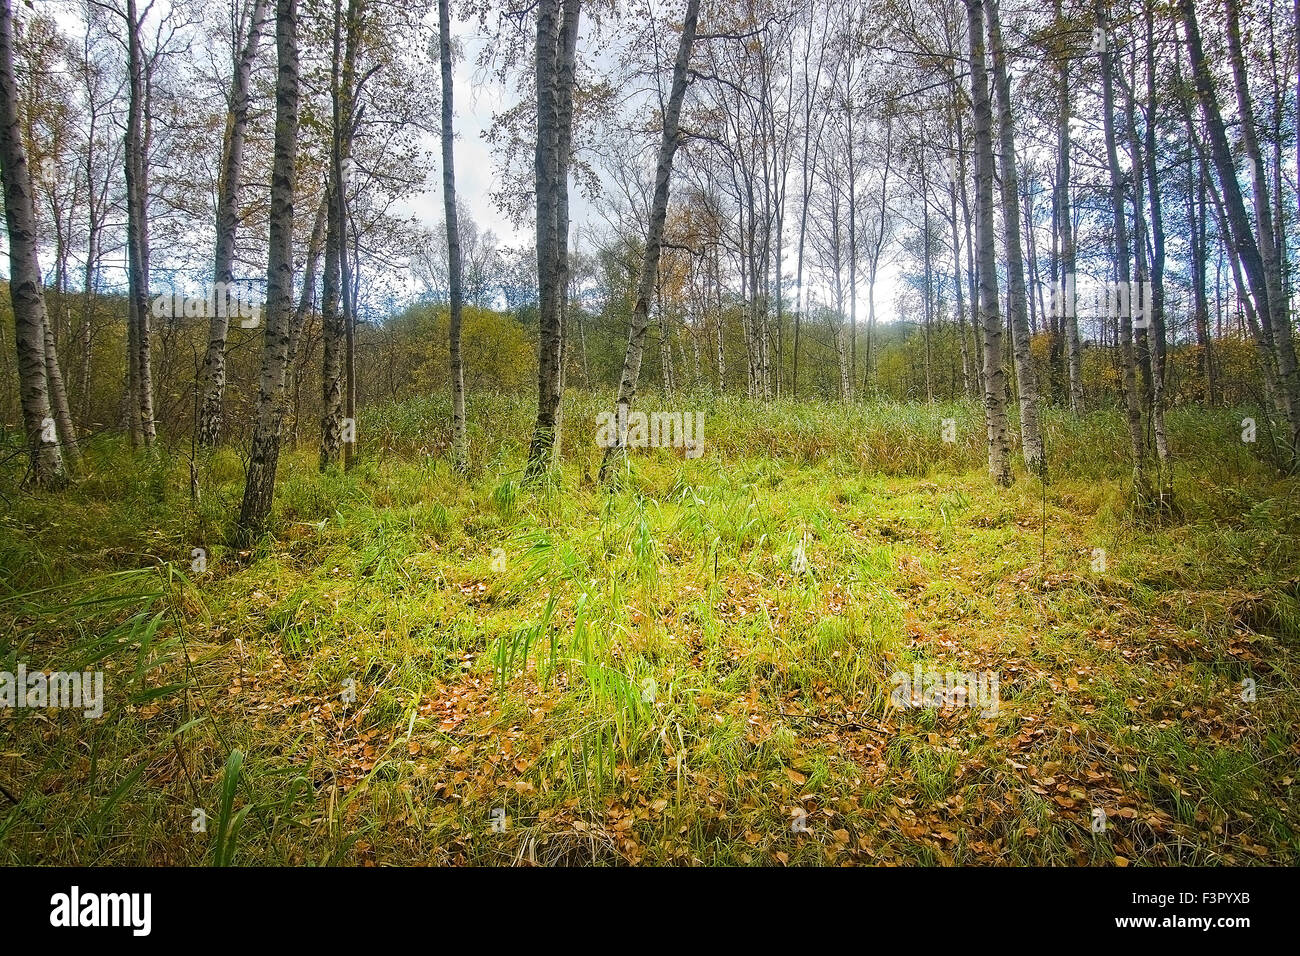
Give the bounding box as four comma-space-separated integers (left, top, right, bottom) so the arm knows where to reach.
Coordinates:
0, 395, 1300, 865
